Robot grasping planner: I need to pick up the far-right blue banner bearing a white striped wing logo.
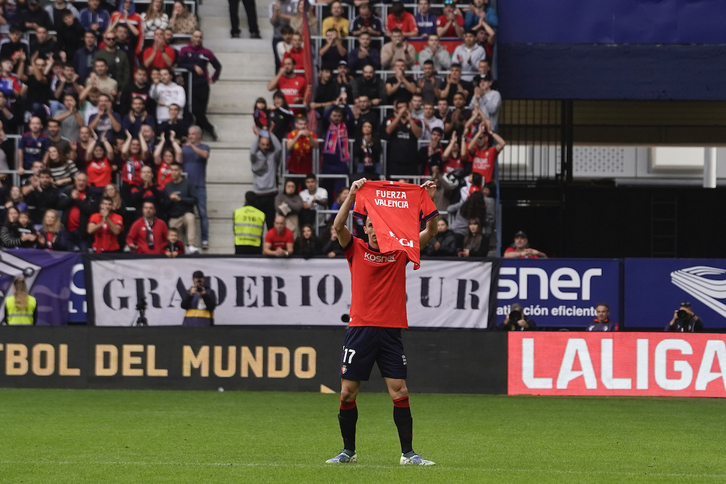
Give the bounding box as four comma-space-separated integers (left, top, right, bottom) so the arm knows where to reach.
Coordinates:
624, 259, 726, 331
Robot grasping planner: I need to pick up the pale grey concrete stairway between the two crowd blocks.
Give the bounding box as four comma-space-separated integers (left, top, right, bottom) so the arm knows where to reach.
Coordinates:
199, 0, 274, 254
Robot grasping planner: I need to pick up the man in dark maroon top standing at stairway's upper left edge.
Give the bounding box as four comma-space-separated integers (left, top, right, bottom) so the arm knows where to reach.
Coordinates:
179, 29, 222, 141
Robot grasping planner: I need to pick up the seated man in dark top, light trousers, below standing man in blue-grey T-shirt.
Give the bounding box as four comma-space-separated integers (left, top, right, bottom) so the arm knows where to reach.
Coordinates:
164, 162, 197, 254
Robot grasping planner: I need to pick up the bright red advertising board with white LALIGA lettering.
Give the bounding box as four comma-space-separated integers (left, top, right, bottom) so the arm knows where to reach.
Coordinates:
508, 332, 726, 397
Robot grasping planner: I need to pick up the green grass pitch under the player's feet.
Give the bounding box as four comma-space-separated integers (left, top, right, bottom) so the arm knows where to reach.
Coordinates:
0, 387, 726, 484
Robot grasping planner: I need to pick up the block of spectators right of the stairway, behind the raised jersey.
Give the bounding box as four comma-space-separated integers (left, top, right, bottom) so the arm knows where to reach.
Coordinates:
242, 0, 505, 257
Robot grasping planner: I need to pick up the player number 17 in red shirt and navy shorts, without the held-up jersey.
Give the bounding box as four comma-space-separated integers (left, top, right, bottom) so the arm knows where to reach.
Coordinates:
327, 178, 438, 465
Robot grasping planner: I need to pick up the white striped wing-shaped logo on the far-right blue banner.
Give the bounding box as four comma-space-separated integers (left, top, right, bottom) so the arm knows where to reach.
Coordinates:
671, 266, 726, 317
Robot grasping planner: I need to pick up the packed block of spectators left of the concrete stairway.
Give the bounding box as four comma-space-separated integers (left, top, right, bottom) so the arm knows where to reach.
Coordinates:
0, 0, 222, 256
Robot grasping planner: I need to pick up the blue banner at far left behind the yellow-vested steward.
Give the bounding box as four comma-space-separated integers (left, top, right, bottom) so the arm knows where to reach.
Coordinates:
0, 249, 80, 326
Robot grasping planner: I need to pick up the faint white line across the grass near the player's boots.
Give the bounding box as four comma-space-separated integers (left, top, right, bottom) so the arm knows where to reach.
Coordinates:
0, 460, 726, 479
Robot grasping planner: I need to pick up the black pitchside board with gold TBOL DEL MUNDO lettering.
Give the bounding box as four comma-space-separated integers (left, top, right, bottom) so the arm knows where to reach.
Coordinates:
0, 327, 507, 394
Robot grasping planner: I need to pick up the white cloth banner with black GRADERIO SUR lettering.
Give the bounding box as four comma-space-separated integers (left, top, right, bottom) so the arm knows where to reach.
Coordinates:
90, 257, 492, 328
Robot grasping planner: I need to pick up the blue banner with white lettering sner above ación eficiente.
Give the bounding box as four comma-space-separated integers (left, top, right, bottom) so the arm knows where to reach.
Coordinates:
496, 259, 620, 328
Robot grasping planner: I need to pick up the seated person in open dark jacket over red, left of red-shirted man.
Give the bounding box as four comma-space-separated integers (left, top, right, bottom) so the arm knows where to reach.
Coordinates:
59, 172, 98, 252
